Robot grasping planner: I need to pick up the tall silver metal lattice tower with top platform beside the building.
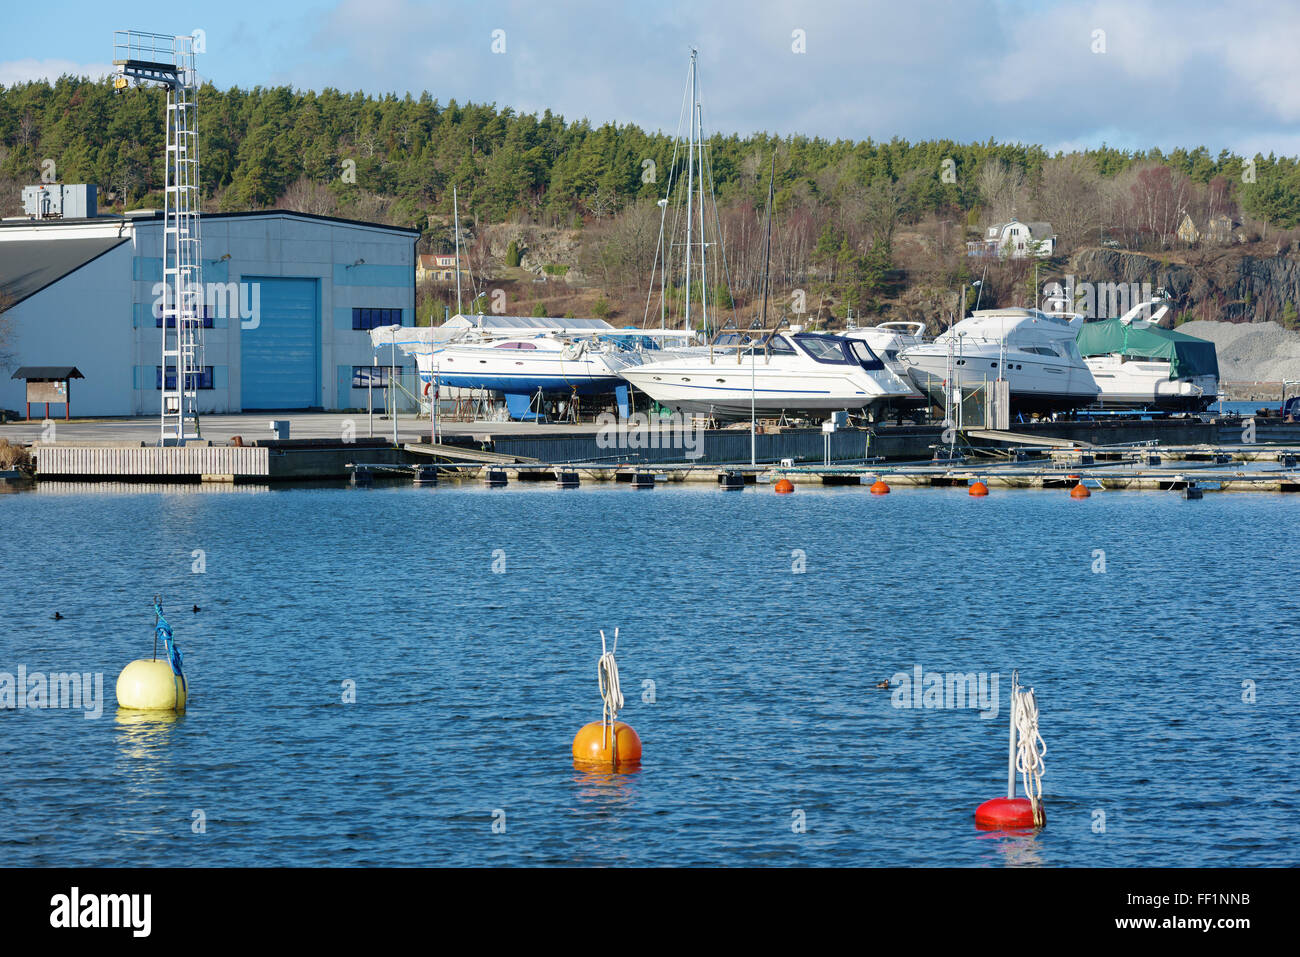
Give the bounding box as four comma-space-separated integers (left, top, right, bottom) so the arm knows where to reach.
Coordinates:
113, 30, 205, 445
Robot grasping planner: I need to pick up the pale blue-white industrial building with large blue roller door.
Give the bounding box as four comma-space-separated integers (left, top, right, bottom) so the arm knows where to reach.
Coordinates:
0, 209, 419, 416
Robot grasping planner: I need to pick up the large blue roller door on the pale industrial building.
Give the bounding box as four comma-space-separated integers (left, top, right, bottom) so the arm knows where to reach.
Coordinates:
239, 276, 321, 410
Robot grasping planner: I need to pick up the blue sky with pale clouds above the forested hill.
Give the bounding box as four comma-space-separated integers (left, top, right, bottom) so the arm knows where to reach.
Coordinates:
0, 0, 1300, 155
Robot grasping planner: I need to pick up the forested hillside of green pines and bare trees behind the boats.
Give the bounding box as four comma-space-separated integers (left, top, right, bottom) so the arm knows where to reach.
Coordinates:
0, 78, 1300, 328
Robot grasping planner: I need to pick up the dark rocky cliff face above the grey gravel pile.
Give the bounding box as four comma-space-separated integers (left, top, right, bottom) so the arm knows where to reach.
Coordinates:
1069, 247, 1300, 322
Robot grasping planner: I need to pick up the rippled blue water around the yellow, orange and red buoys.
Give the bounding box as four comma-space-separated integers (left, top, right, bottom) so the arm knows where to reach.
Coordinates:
0, 485, 1300, 866
